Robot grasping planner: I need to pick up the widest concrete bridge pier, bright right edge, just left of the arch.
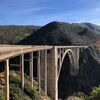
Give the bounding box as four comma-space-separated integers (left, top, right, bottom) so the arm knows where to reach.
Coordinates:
47, 47, 58, 100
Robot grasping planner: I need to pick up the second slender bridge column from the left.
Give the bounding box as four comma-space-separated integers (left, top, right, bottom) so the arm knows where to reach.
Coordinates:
20, 54, 24, 89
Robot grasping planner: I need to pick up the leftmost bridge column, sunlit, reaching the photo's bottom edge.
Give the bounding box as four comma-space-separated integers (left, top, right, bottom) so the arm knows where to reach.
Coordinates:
5, 59, 9, 100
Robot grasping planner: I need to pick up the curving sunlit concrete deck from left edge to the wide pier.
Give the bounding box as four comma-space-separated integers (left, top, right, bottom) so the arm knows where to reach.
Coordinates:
0, 45, 53, 61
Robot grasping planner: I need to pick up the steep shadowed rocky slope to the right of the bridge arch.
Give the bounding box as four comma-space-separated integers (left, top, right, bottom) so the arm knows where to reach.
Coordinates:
76, 46, 100, 94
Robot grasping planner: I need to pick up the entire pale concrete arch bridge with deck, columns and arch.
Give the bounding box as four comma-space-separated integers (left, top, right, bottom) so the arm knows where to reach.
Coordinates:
0, 45, 88, 100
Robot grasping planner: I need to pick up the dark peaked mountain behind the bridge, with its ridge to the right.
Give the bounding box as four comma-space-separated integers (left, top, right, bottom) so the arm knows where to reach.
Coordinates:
19, 22, 100, 45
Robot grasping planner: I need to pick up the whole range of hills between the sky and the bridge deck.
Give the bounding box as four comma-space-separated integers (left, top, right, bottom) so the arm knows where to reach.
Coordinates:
0, 21, 100, 45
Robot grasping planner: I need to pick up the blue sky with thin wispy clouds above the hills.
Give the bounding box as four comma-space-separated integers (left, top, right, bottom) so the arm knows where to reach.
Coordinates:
0, 0, 100, 26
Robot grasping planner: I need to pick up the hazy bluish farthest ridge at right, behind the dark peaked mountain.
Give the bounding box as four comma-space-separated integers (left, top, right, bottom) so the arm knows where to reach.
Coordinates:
73, 22, 100, 34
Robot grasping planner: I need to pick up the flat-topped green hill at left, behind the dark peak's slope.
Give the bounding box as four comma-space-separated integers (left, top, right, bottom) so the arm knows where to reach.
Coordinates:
0, 25, 40, 44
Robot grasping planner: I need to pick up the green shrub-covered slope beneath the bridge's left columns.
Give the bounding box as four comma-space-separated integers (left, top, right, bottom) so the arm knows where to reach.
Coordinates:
0, 71, 51, 100
